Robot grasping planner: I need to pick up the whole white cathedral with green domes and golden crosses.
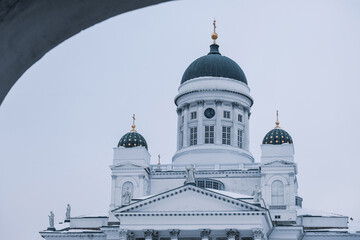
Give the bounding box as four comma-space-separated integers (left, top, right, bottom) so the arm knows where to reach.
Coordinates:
40, 23, 360, 240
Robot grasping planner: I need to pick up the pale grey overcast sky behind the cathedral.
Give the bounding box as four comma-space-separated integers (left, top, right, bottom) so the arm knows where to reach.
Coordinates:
0, 0, 360, 240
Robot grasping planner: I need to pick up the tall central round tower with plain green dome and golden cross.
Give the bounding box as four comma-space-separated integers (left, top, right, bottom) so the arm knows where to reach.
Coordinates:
173, 21, 254, 166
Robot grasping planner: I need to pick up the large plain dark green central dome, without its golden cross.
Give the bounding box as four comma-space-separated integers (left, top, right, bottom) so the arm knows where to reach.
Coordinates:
181, 44, 247, 84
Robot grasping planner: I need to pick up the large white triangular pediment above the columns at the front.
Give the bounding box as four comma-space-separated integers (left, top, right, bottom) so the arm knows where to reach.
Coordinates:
113, 185, 265, 213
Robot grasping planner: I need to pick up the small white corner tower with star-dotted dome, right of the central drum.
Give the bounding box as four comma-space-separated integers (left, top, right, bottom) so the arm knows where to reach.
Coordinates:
261, 113, 302, 223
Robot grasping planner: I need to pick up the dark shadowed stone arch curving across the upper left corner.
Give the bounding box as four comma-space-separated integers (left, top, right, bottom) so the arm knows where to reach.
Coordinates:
0, 0, 170, 104
